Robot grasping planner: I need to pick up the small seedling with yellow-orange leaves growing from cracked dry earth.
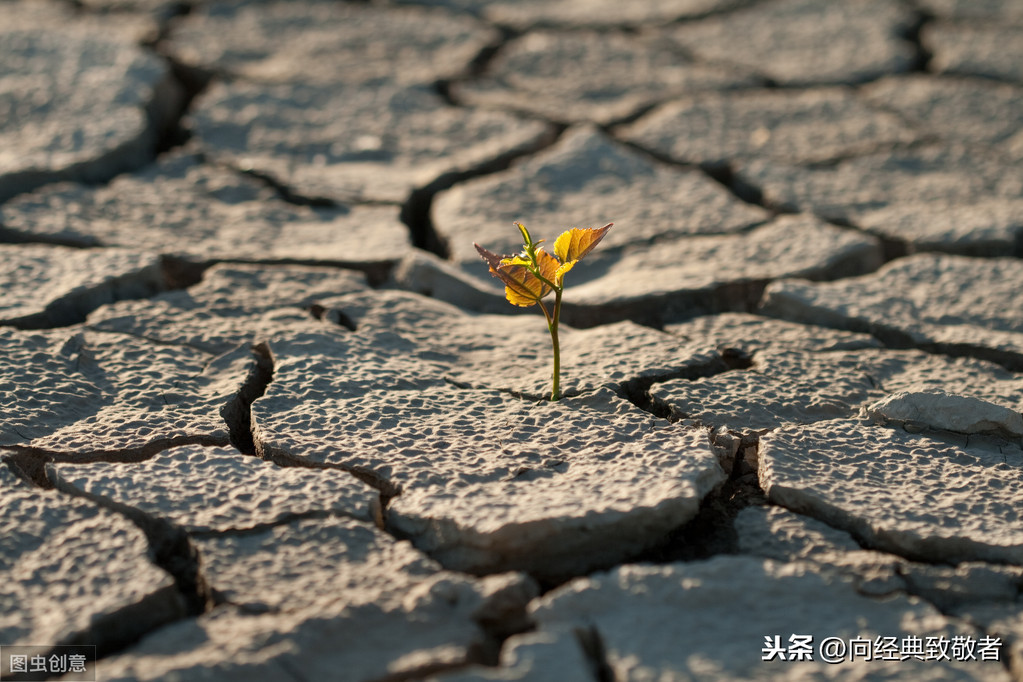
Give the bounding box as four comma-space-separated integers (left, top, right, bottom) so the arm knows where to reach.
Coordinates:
473, 223, 614, 400
